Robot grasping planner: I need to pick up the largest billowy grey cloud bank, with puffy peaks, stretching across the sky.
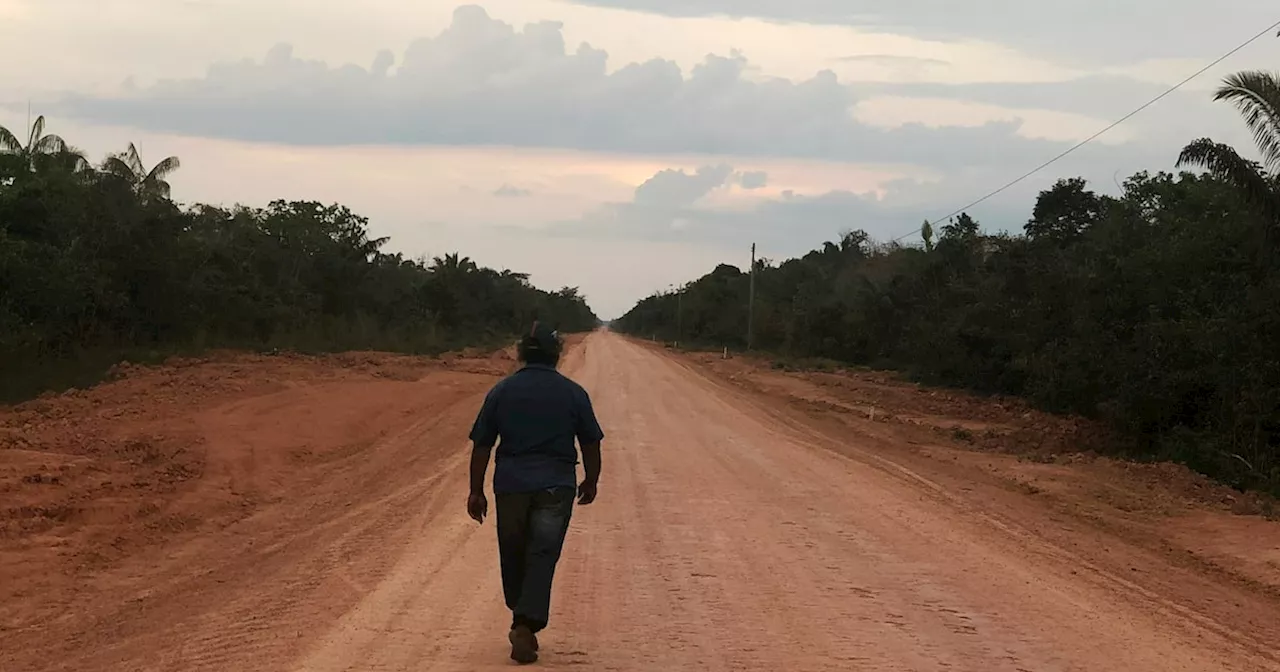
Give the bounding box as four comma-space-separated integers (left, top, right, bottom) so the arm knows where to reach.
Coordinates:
42, 6, 1121, 168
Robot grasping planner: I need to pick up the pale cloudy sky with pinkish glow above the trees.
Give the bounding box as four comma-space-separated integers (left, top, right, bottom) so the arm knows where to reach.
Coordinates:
0, 0, 1280, 319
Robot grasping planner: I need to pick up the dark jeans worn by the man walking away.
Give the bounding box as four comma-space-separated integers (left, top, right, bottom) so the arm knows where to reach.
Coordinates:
494, 488, 577, 632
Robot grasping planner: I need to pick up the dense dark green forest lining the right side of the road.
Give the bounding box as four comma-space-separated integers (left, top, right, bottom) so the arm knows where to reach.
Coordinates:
613, 66, 1280, 493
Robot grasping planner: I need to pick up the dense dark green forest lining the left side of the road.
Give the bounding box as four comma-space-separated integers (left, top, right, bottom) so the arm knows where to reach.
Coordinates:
0, 118, 596, 399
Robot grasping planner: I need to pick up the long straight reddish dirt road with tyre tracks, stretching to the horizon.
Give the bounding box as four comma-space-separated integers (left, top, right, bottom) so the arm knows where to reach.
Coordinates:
0, 334, 1280, 672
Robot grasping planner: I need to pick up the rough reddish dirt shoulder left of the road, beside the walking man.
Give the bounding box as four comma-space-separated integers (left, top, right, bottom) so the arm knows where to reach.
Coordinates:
0, 351, 515, 655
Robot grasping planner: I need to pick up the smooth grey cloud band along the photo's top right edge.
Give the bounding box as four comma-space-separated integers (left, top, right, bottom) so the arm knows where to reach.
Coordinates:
560, 0, 1276, 64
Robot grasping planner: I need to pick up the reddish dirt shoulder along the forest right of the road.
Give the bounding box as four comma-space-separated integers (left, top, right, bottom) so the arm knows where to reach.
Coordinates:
649, 344, 1280, 596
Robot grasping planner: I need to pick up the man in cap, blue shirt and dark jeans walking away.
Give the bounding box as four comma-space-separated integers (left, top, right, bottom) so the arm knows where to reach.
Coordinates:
467, 321, 604, 664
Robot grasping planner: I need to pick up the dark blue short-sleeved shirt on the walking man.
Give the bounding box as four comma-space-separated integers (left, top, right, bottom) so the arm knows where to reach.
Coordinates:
471, 365, 604, 494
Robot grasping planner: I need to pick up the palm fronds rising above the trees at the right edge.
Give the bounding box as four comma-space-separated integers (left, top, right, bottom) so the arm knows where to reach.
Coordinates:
1178, 70, 1280, 220
